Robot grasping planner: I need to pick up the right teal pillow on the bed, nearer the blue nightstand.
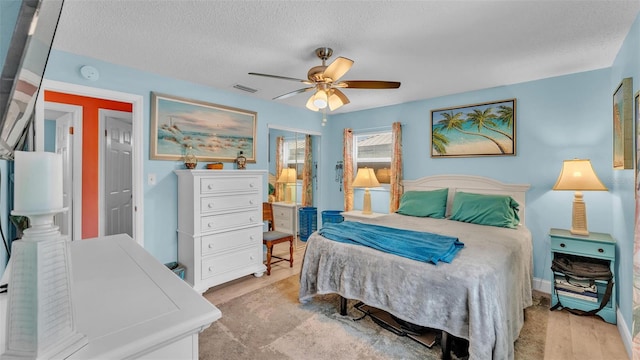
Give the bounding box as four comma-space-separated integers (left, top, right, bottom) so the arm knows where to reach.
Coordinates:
451, 192, 520, 229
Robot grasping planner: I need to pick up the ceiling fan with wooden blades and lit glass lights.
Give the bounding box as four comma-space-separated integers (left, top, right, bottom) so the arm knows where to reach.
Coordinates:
249, 47, 400, 111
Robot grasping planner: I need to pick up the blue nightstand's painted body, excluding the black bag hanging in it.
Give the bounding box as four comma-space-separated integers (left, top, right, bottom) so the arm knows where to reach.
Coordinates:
549, 229, 617, 324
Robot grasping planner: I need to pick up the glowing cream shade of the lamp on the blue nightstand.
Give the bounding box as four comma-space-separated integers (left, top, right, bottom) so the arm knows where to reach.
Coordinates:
553, 159, 607, 191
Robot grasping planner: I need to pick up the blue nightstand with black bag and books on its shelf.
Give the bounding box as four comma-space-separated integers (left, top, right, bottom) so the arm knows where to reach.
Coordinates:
549, 229, 617, 324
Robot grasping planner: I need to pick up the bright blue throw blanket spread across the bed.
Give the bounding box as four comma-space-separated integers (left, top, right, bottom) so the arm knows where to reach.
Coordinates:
318, 221, 464, 264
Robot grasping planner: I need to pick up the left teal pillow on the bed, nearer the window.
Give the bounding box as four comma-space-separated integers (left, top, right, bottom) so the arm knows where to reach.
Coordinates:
396, 189, 449, 219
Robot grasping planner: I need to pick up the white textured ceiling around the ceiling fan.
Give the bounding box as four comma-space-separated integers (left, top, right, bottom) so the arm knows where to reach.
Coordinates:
54, 0, 640, 112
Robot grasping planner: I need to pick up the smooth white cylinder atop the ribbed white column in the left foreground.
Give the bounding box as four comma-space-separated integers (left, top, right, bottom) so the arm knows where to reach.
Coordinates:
13, 151, 63, 215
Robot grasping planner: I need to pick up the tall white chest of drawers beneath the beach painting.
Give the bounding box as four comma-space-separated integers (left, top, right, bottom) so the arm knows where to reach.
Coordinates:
175, 170, 266, 293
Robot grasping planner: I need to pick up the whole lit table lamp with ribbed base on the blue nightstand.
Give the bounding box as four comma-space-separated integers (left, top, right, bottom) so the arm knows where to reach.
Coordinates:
553, 159, 608, 236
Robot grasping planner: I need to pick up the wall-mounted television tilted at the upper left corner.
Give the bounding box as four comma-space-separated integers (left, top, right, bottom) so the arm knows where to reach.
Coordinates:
0, 0, 63, 160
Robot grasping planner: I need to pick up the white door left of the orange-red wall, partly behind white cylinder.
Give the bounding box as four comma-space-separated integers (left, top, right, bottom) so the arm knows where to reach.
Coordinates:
55, 113, 73, 239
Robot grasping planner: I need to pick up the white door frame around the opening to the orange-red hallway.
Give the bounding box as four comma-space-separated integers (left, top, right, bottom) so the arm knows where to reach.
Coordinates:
34, 79, 144, 247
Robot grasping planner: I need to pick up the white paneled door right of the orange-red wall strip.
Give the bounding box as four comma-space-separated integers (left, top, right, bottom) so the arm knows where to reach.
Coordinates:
100, 110, 133, 237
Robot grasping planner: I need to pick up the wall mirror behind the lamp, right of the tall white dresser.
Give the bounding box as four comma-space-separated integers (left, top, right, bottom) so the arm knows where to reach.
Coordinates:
269, 127, 320, 207
